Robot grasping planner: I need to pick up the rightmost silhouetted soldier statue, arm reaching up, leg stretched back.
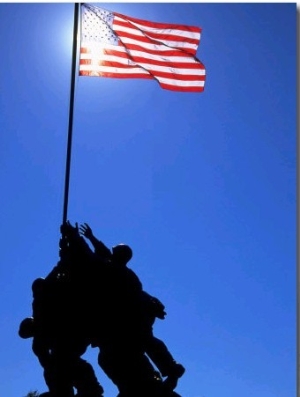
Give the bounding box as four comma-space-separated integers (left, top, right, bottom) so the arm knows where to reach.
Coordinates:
79, 224, 185, 390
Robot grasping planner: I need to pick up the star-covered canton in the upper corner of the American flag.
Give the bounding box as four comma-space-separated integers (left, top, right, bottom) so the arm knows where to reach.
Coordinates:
81, 5, 119, 45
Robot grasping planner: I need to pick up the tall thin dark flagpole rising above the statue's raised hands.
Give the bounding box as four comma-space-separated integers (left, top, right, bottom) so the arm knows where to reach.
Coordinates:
63, 3, 80, 224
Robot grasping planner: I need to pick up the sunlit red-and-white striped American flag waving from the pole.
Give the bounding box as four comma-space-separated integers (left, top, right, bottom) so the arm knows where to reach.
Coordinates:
79, 4, 205, 92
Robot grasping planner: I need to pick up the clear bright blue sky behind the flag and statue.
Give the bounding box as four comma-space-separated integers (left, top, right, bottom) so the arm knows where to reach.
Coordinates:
0, 3, 296, 397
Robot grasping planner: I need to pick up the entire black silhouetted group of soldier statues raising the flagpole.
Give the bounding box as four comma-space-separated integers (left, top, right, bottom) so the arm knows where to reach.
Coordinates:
19, 222, 185, 397
